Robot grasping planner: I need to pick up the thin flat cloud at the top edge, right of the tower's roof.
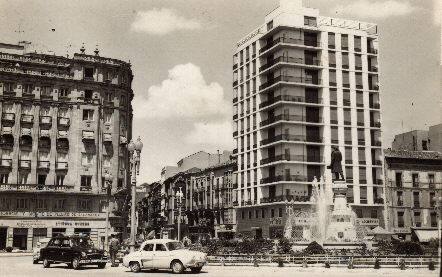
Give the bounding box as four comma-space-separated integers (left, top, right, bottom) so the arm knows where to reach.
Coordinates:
334, 0, 417, 19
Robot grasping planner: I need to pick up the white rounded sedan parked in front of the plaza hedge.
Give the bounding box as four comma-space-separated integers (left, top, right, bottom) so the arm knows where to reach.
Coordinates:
123, 239, 207, 273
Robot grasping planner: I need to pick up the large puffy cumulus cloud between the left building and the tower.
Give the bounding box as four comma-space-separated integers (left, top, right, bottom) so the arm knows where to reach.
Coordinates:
134, 63, 231, 119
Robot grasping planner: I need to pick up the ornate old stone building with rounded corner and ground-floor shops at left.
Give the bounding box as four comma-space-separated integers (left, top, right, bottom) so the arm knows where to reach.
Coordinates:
0, 44, 133, 250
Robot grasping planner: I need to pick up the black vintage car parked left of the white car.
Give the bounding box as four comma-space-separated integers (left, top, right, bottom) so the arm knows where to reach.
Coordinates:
40, 236, 108, 269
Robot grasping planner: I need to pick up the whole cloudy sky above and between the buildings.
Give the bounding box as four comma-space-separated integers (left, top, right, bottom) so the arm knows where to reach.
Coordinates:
0, 0, 442, 183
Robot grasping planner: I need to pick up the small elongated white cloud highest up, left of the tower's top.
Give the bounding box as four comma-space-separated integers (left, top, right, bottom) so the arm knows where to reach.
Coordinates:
131, 8, 202, 35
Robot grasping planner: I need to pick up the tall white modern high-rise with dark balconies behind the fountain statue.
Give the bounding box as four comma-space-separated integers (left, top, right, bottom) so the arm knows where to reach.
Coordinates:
233, 1, 384, 237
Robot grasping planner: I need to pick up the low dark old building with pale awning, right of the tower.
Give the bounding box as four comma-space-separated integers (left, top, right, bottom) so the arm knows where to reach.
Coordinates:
384, 149, 442, 242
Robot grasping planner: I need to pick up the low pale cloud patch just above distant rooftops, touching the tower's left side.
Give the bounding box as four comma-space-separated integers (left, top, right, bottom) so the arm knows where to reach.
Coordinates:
185, 120, 233, 149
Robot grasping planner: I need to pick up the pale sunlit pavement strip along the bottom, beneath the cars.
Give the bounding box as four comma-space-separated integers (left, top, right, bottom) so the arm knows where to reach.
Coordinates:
0, 256, 439, 277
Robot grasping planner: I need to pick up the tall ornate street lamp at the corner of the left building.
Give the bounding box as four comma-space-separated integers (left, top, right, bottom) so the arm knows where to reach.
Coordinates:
127, 137, 143, 252
